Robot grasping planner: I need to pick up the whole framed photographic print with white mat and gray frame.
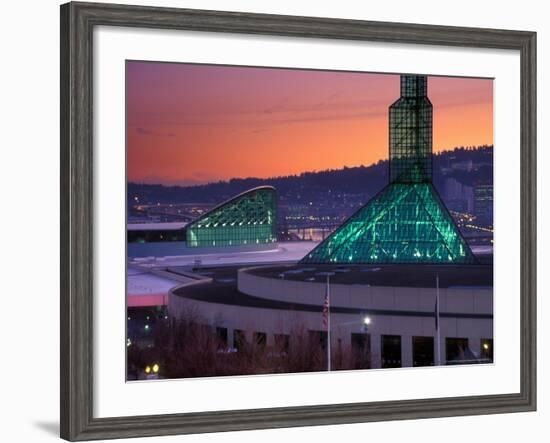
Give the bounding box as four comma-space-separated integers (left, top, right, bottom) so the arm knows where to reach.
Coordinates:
61, 3, 536, 440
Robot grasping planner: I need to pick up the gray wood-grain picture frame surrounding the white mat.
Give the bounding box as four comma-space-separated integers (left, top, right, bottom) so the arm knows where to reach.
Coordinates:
60, 3, 536, 441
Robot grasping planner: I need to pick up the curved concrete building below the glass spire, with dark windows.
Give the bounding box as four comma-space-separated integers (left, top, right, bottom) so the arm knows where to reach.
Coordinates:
168, 265, 493, 368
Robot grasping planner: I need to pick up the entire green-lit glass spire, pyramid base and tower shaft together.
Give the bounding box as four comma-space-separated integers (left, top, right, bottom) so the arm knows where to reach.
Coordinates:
301, 76, 476, 264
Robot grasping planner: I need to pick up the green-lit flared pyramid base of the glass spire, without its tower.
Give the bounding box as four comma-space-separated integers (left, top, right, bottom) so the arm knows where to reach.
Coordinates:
302, 183, 476, 264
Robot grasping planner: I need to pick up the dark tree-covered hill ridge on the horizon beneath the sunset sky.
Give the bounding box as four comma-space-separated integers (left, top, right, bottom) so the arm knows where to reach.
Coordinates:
128, 146, 493, 208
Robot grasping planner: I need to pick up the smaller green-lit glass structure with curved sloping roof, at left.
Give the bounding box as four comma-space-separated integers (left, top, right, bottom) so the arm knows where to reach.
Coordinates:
186, 186, 277, 248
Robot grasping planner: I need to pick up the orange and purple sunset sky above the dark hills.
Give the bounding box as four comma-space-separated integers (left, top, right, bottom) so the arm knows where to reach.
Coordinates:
127, 62, 493, 185
